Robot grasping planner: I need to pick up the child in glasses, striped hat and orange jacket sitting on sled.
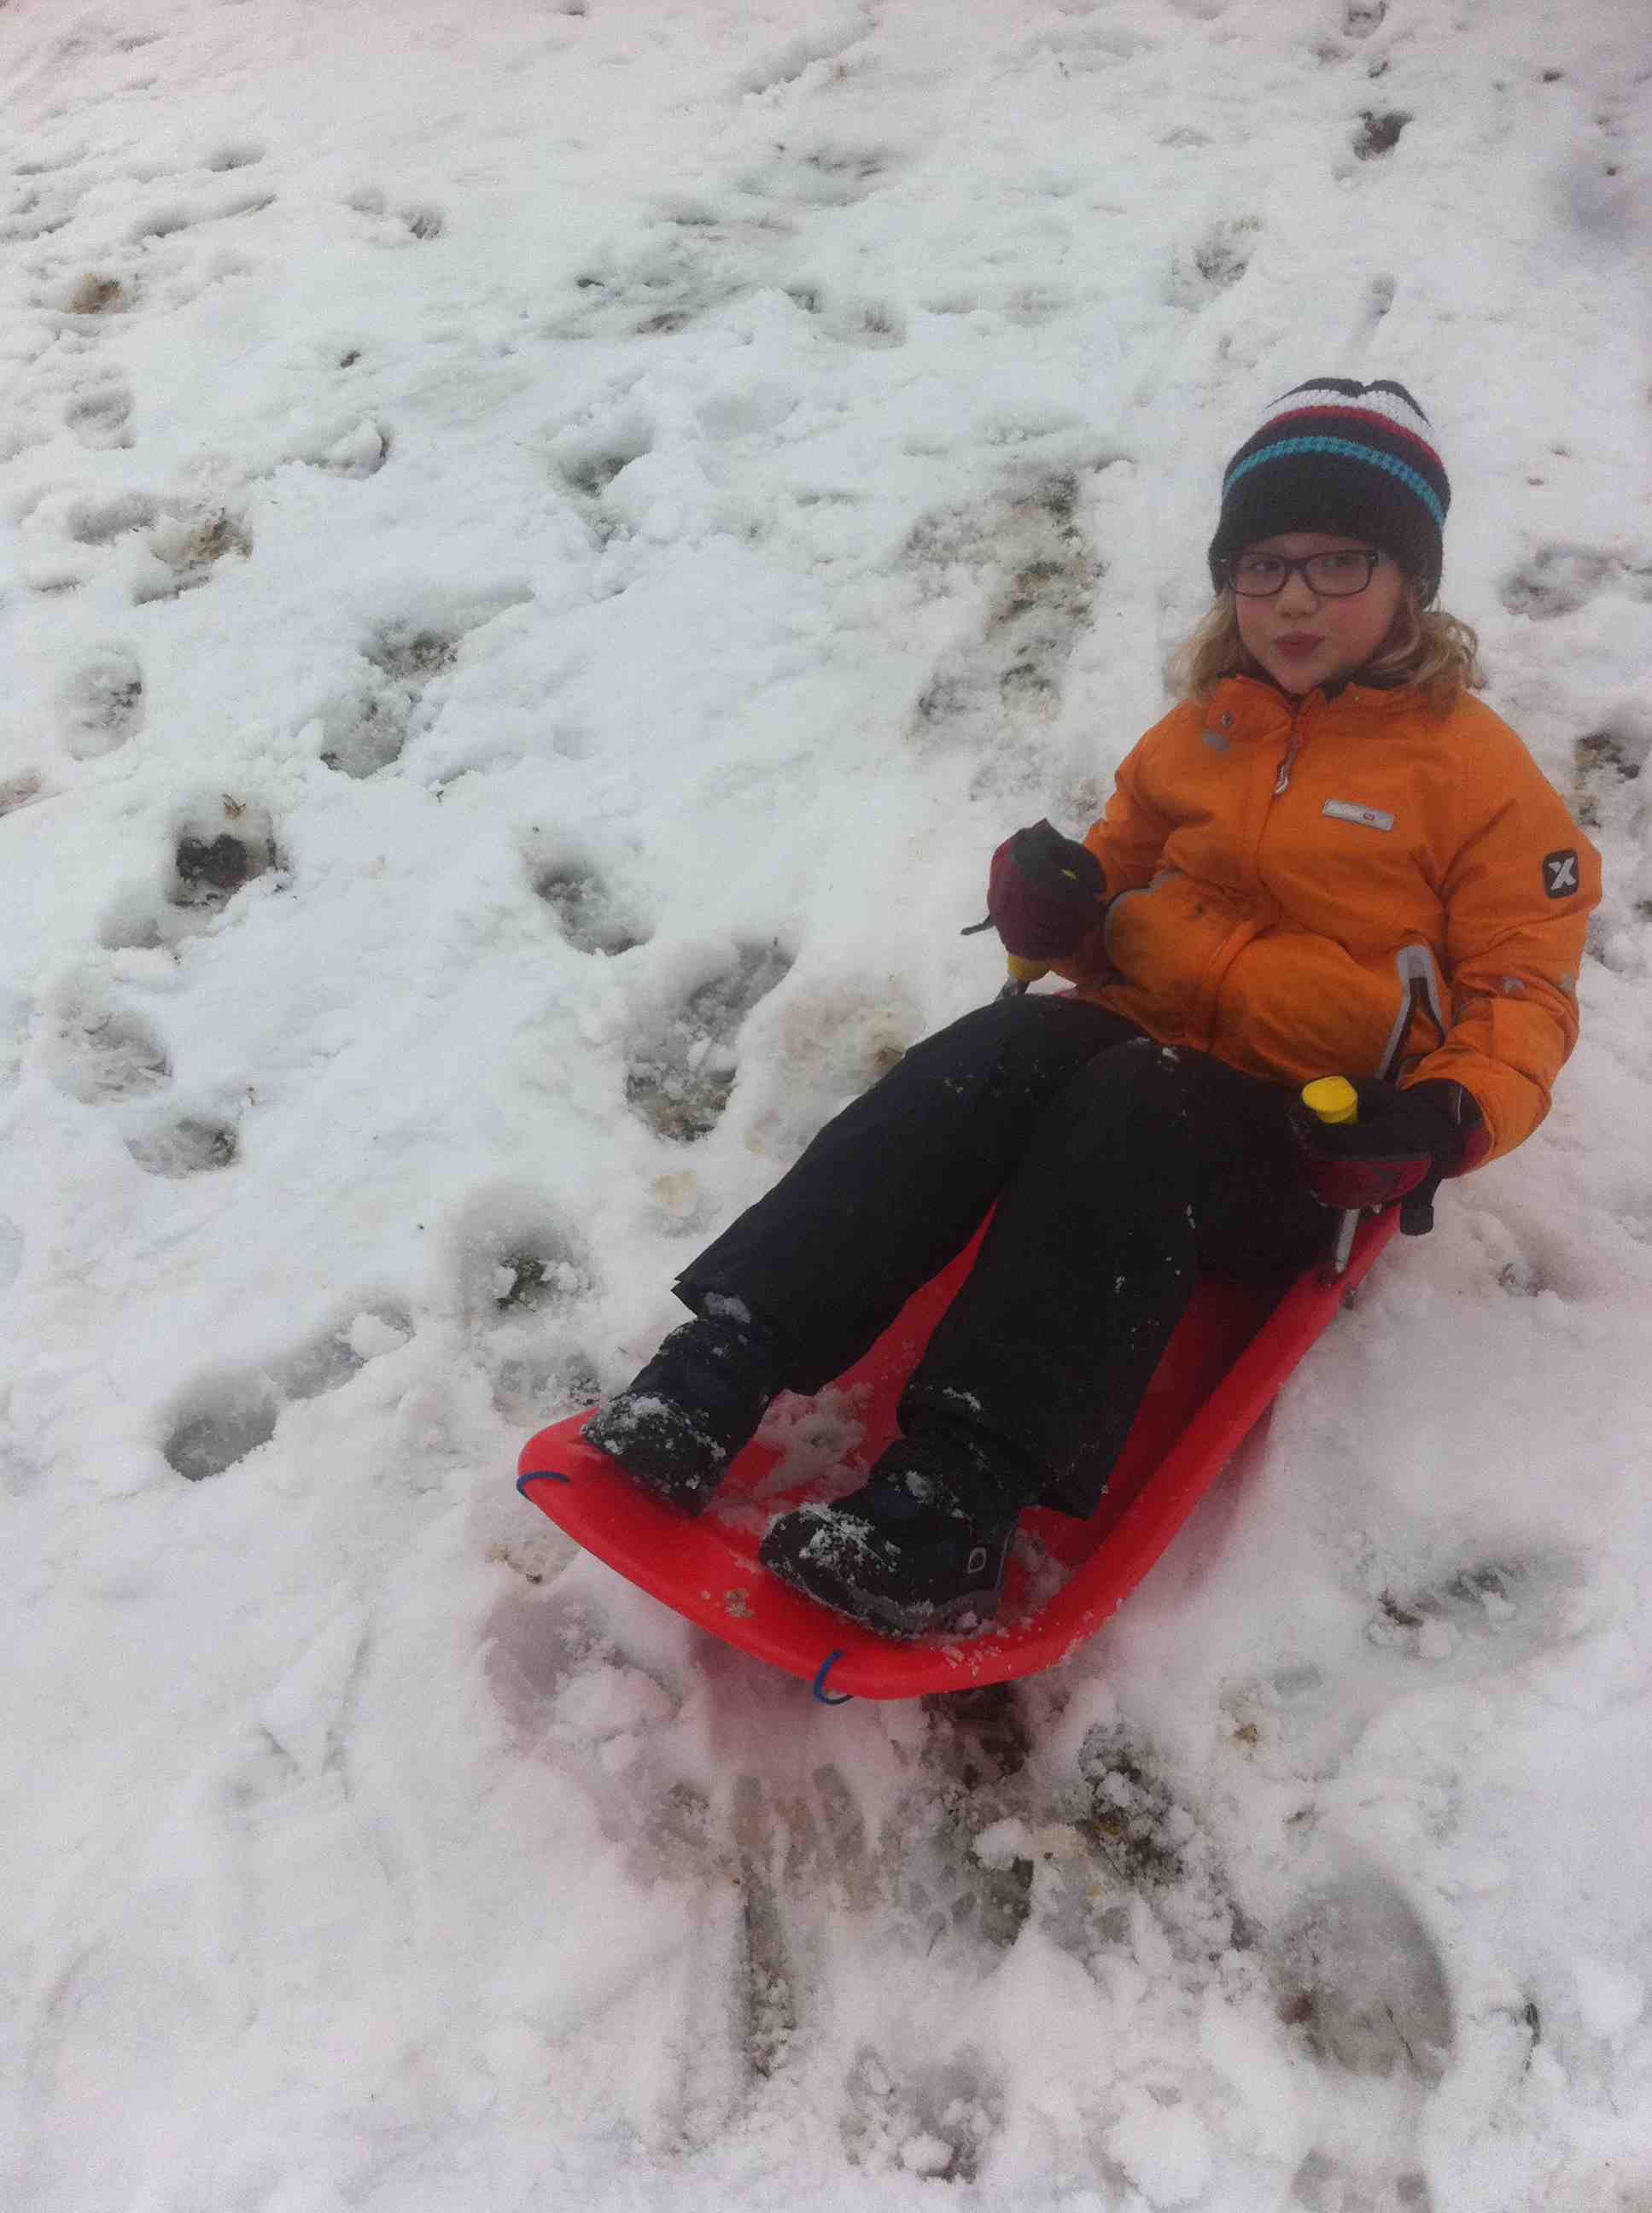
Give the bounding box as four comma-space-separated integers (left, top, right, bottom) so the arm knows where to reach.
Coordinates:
584, 377, 1599, 1635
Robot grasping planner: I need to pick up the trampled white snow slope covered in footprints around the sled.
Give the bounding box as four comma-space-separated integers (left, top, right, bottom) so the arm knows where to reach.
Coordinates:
0, 0, 1652, 2213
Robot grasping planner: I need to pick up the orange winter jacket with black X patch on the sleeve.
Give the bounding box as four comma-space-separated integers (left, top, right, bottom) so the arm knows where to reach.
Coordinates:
1061, 677, 1601, 1155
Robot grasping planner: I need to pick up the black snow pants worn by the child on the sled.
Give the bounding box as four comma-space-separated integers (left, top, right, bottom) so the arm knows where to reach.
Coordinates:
674, 996, 1329, 1511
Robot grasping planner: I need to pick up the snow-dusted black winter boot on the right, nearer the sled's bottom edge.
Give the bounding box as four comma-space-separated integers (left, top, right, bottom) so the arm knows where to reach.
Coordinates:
758, 1423, 1042, 1638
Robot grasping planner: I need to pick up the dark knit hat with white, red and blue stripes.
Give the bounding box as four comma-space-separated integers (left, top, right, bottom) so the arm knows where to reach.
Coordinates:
1210, 377, 1451, 602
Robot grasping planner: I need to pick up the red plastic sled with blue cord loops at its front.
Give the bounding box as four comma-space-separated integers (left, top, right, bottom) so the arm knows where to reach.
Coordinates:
517, 1208, 1396, 1702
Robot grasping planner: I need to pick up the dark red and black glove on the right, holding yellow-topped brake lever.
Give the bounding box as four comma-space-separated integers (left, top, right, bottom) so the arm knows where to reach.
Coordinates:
1292, 1076, 1491, 1237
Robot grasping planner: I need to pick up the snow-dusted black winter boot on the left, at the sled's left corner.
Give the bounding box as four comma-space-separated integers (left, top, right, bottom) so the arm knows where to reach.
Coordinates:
580, 1299, 783, 1514
